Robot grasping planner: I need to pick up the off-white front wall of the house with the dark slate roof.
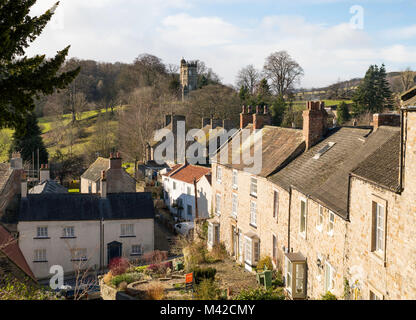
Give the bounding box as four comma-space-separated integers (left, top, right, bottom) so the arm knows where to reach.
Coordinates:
17, 219, 154, 279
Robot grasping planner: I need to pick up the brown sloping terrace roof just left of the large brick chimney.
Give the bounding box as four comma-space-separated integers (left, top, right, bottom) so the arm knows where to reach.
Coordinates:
213, 124, 305, 177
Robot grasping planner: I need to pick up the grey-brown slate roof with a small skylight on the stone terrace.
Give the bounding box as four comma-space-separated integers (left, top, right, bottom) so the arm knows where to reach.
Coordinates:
269, 126, 399, 219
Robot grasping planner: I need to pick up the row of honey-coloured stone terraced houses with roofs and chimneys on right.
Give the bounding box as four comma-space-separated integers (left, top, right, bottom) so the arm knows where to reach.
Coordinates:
208, 88, 416, 299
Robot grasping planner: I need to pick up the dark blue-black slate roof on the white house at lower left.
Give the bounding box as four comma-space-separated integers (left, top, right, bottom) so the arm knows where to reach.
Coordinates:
18, 192, 154, 221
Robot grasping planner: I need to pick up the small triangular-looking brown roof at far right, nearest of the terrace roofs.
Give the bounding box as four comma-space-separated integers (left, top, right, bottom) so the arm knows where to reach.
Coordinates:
352, 132, 400, 192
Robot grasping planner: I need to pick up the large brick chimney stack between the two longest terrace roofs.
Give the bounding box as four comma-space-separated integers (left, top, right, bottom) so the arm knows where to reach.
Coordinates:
303, 101, 328, 150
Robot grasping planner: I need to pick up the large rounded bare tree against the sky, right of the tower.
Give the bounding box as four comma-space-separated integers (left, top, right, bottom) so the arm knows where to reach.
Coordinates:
263, 51, 304, 96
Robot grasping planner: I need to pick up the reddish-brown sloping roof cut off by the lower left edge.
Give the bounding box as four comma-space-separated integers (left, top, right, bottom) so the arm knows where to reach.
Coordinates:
0, 225, 36, 281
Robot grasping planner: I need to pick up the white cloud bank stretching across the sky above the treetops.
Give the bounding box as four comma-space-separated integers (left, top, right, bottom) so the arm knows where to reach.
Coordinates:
28, 0, 415, 87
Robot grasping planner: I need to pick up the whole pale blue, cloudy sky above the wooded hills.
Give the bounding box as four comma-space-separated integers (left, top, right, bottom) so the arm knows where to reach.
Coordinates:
28, 0, 416, 87
